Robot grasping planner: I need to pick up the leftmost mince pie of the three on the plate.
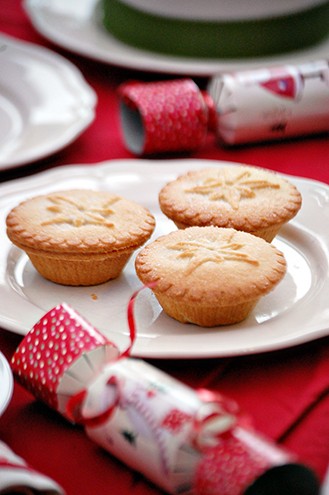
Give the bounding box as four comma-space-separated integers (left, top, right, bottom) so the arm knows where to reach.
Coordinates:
6, 189, 155, 285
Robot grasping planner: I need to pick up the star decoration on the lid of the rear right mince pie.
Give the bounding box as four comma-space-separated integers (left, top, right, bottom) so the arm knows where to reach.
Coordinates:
186, 171, 280, 210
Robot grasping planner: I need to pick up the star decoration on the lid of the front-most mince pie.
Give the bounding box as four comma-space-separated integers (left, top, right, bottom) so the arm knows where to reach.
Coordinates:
169, 240, 259, 274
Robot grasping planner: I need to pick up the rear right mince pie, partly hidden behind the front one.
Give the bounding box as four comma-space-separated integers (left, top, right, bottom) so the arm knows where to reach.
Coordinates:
159, 165, 302, 241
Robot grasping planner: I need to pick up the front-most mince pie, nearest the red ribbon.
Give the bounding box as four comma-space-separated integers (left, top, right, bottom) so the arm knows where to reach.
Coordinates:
135, 226, 286, 326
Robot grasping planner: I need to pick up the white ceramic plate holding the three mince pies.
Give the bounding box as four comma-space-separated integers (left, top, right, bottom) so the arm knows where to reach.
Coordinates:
0, 160, 329, 358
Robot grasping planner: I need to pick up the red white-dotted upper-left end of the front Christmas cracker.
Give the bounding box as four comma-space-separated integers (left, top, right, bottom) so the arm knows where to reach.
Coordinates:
11, 304, 119, 415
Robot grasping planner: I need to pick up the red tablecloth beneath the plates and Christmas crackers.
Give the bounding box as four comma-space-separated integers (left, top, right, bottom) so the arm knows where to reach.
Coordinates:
0, 0, 329, 495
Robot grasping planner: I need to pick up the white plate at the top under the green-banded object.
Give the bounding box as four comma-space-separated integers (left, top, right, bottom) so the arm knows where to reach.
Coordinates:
24, 0, 329, 76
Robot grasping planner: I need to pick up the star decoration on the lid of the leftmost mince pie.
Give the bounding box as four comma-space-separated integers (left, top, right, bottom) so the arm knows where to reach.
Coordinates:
42, 196, 119, 228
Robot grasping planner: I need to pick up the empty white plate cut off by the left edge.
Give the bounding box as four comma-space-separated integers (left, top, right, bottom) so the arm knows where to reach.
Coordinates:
0, 35, 96, 170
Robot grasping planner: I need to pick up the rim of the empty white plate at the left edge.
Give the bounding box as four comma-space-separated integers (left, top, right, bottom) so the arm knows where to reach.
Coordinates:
0, 33, 97, 170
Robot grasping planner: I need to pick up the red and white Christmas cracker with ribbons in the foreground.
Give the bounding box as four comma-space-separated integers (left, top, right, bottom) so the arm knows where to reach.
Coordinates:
12, 304, 300, 495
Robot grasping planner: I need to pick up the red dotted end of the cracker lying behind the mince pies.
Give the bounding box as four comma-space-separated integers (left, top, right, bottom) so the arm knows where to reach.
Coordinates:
119, 79, 216, 155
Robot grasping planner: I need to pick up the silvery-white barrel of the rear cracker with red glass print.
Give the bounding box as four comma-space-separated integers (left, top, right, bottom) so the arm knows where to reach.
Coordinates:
207, 60, 329, 145
